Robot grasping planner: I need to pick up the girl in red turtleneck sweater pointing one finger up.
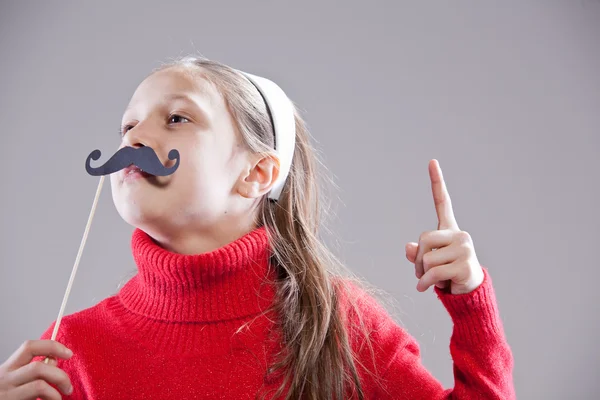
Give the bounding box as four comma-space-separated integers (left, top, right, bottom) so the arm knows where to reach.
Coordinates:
0, 57, 515, 400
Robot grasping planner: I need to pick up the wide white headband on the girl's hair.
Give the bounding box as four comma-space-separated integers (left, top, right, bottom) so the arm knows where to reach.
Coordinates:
238, 70, 296, 200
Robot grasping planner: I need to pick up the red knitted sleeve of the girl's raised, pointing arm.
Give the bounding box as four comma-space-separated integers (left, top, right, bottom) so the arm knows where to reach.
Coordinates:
346, 268, 516, 400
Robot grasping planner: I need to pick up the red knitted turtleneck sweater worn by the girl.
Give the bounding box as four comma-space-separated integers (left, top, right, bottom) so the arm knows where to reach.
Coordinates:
33, 228, 515, 400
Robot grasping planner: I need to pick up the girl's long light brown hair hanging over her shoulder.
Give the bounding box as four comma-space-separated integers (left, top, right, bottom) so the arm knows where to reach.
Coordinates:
153, 56, 390, 400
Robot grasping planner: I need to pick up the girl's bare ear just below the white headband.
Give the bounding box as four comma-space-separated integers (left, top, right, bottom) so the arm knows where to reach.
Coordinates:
237, 154, 280, 199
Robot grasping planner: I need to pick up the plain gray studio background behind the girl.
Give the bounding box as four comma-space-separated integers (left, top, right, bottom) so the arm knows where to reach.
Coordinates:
0, 0, 600, 399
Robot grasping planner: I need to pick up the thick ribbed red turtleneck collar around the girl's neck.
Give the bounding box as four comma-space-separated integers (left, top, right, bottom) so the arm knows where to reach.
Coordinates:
118, 227, 275, 322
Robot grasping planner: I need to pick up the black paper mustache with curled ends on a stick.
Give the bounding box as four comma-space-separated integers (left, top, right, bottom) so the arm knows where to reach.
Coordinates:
85, 146, 179, 176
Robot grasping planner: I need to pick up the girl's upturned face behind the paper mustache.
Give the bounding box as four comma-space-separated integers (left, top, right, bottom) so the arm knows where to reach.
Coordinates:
110, 67, 262, 245
